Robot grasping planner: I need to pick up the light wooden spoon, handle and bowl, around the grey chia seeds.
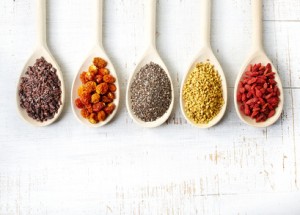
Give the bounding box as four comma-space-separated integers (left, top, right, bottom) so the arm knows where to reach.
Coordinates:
126, 0, 174, 128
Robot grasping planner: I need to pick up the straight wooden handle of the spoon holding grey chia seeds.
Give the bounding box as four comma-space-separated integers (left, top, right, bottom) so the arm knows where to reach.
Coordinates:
145, 0, 156, 47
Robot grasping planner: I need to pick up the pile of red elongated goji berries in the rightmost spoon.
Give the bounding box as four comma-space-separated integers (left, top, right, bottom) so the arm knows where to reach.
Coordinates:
237, 63, 280, 122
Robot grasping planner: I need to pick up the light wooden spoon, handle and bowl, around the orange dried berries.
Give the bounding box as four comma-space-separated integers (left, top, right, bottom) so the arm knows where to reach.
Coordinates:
71, 0, 120, 128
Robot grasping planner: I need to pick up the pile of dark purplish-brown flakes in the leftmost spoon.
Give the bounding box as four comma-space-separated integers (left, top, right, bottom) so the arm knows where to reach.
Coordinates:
19, 57, 62, 122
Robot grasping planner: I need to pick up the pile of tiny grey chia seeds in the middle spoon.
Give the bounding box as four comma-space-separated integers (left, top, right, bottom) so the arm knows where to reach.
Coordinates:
130, 62, 172, 122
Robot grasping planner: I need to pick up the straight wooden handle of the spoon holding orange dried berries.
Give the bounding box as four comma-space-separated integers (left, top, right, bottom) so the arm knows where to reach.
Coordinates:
95, 0, 103, 47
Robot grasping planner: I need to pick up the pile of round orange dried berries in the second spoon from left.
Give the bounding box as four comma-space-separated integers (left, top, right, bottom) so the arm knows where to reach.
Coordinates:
75, 57, 117, 124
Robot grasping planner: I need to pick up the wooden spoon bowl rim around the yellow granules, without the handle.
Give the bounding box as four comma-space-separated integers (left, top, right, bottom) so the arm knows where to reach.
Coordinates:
180, 48, 227, 128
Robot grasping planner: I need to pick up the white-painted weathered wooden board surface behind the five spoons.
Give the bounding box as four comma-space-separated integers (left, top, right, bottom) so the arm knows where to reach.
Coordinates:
0, 0, 300, 215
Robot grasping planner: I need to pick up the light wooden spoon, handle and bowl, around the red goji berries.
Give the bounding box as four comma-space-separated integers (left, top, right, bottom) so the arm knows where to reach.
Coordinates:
234, 0, 284, 127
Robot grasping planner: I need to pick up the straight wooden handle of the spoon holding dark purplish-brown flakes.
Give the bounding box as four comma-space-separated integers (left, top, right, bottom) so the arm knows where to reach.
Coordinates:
36, 0, 47, 47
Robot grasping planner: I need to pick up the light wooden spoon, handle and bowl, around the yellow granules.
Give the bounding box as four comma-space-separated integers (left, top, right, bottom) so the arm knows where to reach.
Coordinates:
180, 0, 227, 128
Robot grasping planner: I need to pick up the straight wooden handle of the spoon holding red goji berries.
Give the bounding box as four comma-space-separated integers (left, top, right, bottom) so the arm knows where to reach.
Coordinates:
252, 0, 263, 50
